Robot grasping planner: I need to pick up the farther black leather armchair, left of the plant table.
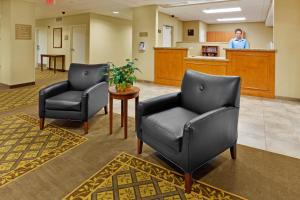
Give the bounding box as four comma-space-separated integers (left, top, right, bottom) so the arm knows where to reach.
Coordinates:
39, 64, 109, 134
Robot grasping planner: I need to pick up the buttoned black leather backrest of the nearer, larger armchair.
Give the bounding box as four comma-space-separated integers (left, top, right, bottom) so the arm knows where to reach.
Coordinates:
181, 70, 240, 114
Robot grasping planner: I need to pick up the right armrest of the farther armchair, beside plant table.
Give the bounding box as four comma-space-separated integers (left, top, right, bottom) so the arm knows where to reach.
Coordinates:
82, 82, 108, 121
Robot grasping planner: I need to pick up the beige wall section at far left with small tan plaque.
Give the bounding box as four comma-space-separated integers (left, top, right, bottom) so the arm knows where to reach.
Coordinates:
0, 0, 35, 85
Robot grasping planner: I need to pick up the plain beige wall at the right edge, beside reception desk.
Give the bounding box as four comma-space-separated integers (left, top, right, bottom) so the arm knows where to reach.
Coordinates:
274, 0, 300, 99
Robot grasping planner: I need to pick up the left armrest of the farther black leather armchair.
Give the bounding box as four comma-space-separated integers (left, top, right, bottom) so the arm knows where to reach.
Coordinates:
39, 81, 69, 118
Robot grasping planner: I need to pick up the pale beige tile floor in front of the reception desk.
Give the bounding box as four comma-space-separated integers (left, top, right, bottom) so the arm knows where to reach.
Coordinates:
114, 83, 300, 158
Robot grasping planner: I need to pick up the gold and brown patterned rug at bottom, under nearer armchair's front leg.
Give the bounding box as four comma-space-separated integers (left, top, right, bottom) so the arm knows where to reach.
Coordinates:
64, 153, 245, 200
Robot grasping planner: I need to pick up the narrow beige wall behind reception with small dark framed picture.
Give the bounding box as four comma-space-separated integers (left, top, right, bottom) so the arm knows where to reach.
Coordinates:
183, 21, 200, 42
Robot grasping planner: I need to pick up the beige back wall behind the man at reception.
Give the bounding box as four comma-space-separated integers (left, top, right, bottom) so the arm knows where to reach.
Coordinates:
207, 22, 273, 49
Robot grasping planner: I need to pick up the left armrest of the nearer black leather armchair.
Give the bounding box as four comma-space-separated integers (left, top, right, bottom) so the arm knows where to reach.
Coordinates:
135, 92, 181, 137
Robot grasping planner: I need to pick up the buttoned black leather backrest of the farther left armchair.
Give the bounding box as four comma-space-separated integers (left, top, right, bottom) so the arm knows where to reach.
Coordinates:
68, 63, 109, 91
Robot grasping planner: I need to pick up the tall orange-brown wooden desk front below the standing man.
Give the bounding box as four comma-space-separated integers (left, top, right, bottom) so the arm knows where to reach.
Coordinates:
227, 50, 275, 97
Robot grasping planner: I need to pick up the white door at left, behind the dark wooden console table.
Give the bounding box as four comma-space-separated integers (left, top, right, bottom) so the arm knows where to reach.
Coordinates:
35, 27, 48, 67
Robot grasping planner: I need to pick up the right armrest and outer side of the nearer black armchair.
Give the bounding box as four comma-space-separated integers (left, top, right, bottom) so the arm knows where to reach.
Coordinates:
182, 107, 239, 170
